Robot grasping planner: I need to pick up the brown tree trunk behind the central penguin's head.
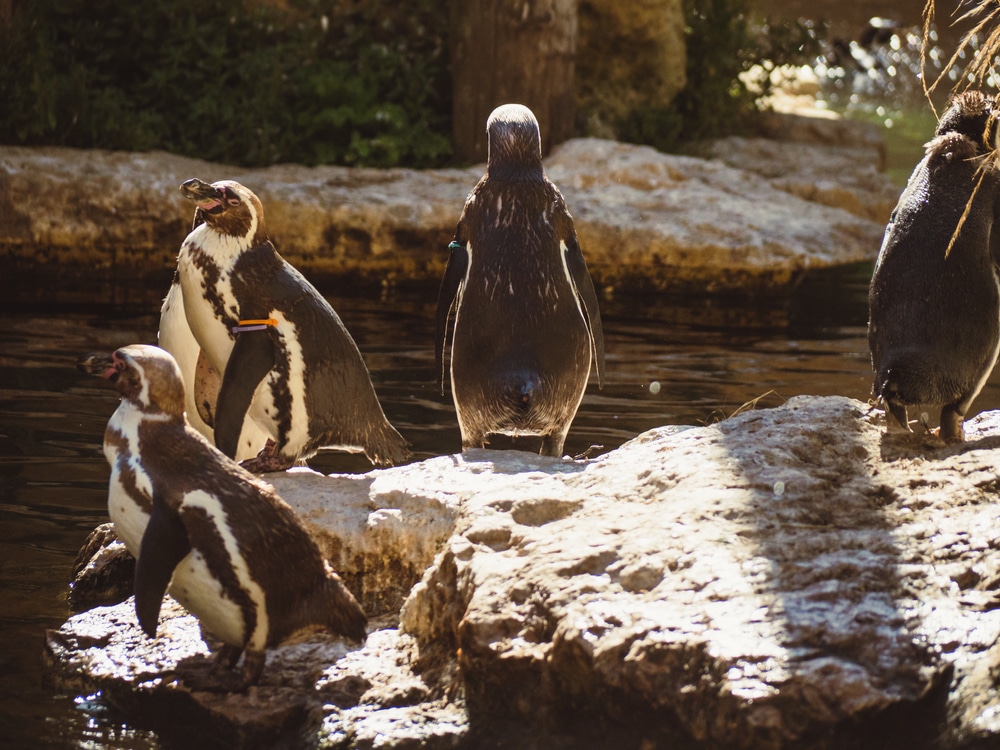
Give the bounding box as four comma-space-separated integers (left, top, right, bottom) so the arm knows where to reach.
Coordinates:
451, 0, 577, 162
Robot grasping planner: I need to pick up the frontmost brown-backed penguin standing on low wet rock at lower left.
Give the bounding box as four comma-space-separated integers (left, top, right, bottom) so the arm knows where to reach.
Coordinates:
79, 345, 367, 692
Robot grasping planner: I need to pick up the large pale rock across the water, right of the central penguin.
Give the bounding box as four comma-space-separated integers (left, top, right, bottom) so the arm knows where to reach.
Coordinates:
546, 139, 895, 292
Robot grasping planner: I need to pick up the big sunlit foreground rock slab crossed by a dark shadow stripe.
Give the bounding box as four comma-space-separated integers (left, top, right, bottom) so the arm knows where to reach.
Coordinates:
402, 397, 1000, 748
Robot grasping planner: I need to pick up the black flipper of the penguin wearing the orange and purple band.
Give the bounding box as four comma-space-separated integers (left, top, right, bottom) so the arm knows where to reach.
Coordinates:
215, 329, 277, 458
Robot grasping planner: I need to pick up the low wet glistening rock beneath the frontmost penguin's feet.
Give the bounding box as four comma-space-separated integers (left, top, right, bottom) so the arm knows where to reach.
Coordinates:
45, 598, 458, 749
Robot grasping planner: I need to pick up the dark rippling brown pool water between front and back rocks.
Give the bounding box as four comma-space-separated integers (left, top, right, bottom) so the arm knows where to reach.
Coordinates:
0, 268, 1000, 748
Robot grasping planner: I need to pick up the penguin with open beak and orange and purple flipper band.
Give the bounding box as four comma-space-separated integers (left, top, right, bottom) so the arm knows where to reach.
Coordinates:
168, 179, 411, 473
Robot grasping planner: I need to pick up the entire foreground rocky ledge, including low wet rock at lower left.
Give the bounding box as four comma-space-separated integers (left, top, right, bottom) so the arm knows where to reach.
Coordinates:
47, 397, 1000, 750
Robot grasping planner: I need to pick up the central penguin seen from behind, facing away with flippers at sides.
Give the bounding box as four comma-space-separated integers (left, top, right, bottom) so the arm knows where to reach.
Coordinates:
435, 104, 604, 456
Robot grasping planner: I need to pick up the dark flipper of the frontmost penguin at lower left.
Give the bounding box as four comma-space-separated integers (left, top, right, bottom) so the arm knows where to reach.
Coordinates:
135, 497, 191, 638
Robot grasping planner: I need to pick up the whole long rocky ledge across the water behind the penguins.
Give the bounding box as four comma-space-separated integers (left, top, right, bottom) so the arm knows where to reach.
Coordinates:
0, 117, 900, 299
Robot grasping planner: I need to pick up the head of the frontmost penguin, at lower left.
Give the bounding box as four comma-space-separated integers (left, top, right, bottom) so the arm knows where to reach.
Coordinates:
77, 344, 184, 419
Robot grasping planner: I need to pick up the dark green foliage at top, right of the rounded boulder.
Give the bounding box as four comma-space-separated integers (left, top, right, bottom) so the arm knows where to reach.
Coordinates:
621, 0, 818, 151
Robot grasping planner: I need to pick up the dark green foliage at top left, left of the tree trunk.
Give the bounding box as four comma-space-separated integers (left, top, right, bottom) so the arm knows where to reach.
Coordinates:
0, 0, 451, 166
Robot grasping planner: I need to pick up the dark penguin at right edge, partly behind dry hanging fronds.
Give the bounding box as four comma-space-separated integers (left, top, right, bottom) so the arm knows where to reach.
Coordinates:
868, 91, 1000, 442
